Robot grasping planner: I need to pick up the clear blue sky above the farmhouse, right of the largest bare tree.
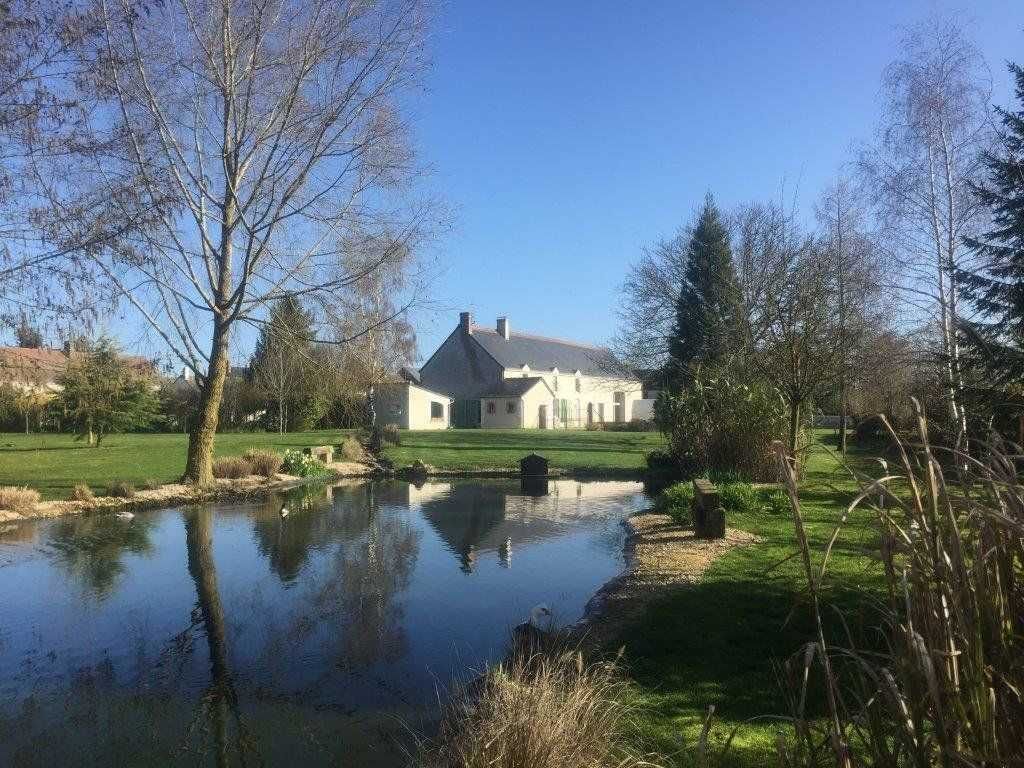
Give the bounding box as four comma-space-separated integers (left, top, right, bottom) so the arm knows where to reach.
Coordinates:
407, 0, 1024, 357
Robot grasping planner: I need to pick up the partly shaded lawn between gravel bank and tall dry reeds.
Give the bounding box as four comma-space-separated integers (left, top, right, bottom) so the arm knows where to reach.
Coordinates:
621, 432, 883, 767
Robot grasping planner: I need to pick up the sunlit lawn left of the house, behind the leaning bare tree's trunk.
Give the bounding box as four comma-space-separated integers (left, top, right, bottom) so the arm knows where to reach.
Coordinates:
0, 430, 347, 499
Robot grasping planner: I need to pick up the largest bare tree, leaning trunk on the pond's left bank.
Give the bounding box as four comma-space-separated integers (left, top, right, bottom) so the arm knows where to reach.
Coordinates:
57, 0, 426, 483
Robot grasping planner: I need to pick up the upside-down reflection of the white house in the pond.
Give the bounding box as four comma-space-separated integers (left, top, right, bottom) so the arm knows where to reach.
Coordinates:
406, 478, 636, 573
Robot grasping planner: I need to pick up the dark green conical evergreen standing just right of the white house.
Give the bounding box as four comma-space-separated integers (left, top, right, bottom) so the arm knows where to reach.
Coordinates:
666, 193, 740, 390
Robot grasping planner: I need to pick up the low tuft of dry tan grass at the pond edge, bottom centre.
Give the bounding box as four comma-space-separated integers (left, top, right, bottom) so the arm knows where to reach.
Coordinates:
420, 652, 656, 768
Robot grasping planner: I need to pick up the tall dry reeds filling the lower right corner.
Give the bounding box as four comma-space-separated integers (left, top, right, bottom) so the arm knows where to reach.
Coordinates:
776, 401, 1024, 768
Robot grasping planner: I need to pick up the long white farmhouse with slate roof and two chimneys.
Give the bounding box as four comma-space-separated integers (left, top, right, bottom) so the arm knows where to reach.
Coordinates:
381, 312, 643, 429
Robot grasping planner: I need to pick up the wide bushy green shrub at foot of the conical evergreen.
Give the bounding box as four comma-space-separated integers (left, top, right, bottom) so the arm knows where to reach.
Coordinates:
654, 371, 788, 480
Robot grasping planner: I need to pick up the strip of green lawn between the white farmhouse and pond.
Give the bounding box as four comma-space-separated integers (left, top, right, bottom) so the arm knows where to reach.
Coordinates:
385, 429, 665, 471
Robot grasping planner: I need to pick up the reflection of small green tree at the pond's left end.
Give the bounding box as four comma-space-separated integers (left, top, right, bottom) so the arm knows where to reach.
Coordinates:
46, 515, 153, 599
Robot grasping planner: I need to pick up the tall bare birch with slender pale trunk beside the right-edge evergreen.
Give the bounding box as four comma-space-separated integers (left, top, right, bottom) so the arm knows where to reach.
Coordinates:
860, 19, 991, 450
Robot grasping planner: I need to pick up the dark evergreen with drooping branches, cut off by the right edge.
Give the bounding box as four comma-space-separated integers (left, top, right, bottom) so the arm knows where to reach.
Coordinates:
959, 65, 1024, 382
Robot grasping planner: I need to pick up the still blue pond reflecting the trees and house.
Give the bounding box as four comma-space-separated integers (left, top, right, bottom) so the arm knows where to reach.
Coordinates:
0, 479, 644, 766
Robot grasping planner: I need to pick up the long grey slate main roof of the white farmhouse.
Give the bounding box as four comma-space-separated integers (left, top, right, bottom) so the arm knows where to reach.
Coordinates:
473, 326, 622, 375
